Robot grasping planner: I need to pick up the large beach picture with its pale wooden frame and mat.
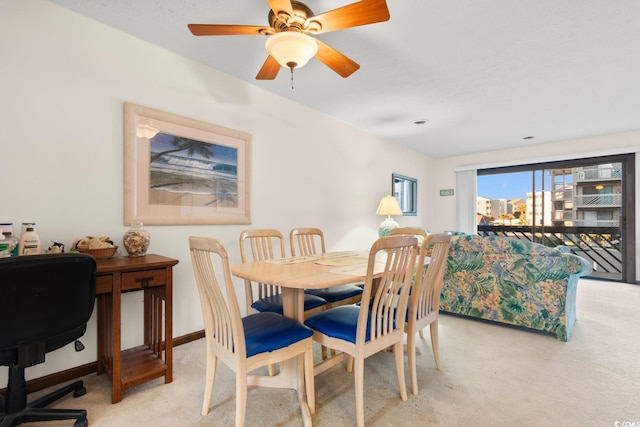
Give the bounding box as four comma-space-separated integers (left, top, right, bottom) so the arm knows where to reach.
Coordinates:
124, 102, 251, 225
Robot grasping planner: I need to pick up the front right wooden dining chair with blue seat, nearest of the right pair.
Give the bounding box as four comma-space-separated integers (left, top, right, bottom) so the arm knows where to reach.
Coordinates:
305, 236, 418, 427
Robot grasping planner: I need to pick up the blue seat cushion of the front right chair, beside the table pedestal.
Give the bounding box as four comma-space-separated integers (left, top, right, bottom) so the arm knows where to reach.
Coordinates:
304, 305, 370, 344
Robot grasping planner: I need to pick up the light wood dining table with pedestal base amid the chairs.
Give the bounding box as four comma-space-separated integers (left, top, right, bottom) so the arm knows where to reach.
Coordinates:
231, 251, 377, 426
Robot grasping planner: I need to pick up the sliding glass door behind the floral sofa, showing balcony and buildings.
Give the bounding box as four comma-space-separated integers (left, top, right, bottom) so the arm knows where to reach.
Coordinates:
477, 154, 635, 283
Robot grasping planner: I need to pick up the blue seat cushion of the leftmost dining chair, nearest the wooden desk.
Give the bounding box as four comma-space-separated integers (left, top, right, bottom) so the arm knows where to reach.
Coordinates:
242, 312, 313, 357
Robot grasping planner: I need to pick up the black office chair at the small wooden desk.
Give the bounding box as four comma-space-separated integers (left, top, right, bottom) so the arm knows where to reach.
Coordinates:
0, 254, 96, 427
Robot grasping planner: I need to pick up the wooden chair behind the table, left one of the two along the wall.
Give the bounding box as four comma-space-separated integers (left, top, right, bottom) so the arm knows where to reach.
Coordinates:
240, 228, 327, 316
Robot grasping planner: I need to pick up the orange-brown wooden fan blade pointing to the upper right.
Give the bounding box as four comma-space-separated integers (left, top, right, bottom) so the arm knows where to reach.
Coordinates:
311, 0, 390, 34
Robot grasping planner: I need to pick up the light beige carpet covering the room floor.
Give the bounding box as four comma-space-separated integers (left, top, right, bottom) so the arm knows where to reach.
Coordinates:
26, 280, 640, 427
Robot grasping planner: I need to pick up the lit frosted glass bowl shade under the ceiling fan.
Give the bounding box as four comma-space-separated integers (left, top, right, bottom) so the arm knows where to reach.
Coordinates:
264, 31, 318, 70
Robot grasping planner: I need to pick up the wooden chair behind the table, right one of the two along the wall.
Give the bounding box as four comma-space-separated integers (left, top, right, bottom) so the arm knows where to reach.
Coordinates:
289, 227, 362, 309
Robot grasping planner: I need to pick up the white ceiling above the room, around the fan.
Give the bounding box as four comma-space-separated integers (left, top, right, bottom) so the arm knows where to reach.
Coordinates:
50, 0, 640, 158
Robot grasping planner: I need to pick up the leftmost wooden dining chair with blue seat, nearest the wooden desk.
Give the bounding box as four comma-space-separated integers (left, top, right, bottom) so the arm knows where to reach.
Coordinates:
189, 237, 315, 427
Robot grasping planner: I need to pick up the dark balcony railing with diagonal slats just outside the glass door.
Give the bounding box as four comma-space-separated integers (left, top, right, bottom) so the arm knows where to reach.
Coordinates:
478, 225, 622, 280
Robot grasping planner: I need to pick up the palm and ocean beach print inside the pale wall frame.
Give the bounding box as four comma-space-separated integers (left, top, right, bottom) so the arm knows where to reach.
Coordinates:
148, 132, 238, 208
